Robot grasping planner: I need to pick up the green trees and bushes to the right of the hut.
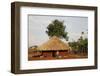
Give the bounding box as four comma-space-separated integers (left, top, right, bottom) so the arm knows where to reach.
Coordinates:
69, 32, 88, 53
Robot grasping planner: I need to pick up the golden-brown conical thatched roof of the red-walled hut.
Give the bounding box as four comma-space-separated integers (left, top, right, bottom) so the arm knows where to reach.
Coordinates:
37, 36, 70, 51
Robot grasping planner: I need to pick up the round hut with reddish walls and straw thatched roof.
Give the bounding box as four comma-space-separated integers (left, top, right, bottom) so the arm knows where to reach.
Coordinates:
37, 36, 71, 57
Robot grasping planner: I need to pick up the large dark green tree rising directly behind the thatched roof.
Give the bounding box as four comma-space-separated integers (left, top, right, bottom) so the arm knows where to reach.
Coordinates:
46, 19, 68, 41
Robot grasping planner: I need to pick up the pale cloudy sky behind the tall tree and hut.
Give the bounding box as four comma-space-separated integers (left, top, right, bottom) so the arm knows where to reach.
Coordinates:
28, 15, 88, 47
